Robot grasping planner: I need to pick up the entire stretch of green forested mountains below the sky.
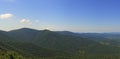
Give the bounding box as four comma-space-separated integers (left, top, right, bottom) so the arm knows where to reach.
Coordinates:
0, 28, 120, 59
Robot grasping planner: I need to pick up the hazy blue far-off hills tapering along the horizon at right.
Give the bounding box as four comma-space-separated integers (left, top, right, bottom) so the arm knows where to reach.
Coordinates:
58, 31, 120, 46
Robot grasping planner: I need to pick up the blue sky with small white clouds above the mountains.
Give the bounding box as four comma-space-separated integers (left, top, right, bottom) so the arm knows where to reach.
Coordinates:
0, 0, 120, 32
